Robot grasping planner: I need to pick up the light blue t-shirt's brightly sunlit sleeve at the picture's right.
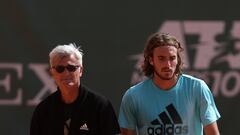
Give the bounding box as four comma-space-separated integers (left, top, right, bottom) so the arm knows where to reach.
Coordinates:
199, 81, 221, 126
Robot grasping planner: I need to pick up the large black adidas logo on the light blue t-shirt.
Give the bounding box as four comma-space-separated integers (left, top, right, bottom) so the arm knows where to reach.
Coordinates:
147, 104, 188, 135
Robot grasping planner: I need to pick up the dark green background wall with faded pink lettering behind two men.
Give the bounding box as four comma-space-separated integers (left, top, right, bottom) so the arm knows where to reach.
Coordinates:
0, 0, 240, 135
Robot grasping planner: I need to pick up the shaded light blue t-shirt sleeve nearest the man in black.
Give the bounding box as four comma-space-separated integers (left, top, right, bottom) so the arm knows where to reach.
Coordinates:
119, 91, 137, 129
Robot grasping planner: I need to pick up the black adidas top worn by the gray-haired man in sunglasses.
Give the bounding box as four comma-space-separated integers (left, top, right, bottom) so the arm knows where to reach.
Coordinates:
30, 85, 120, 135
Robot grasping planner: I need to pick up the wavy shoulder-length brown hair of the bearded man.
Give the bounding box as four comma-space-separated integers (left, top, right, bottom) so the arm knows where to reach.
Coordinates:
142, 33, 183, 77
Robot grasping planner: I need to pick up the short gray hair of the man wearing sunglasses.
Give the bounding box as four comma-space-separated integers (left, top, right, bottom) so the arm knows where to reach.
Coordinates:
49, 43, 83, 66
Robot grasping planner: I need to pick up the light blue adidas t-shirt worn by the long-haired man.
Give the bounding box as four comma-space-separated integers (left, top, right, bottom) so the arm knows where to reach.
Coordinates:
119, 74, 220, 135
